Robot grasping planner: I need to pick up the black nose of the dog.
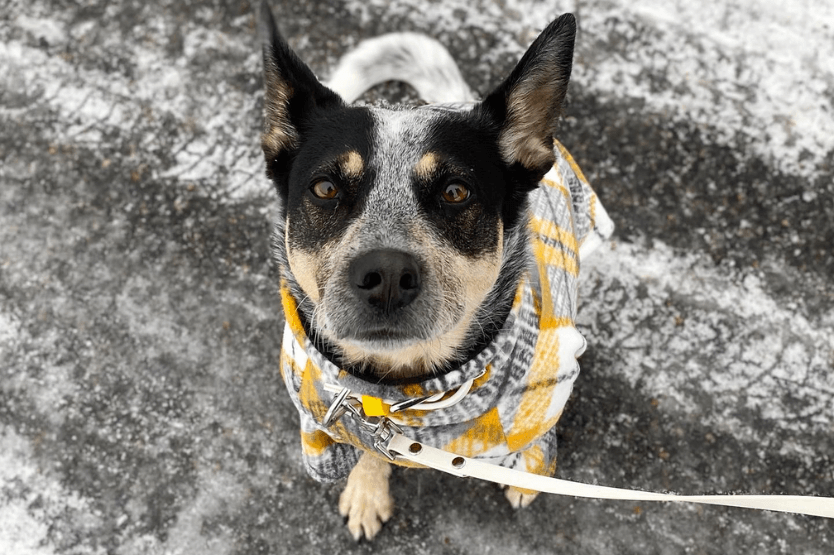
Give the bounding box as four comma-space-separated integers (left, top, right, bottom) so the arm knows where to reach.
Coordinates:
348, 249, 420, 315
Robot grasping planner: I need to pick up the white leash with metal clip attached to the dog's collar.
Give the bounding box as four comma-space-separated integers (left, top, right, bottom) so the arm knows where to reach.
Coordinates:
322, 388, 834, 518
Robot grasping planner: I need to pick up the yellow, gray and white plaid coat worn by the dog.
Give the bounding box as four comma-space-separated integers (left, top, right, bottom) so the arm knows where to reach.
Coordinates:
281, 142, 613, 481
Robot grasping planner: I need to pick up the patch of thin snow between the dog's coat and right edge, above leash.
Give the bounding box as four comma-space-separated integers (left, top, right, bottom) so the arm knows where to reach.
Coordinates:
579, 241, 834, 441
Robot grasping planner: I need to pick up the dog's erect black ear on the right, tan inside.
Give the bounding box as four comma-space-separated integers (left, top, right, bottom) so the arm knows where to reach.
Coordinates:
480, 14, 576, 178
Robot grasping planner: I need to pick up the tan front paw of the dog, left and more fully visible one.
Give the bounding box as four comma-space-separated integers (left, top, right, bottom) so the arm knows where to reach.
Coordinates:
339, 453, 394, 541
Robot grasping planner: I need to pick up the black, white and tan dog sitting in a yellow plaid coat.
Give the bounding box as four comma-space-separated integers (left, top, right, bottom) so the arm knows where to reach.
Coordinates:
261, 2, 612, 540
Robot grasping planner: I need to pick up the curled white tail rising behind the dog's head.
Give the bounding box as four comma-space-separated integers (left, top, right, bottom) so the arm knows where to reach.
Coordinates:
328, 33, 475, 104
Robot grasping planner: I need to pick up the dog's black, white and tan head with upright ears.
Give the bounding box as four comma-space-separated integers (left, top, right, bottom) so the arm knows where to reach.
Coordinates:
262, 2, 575, 378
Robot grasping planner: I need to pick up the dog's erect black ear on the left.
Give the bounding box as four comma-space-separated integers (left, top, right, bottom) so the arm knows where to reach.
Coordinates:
259, 0, 344, 192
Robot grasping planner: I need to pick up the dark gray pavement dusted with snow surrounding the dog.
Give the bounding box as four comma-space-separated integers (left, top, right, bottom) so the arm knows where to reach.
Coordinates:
0, 0, 834, 555
